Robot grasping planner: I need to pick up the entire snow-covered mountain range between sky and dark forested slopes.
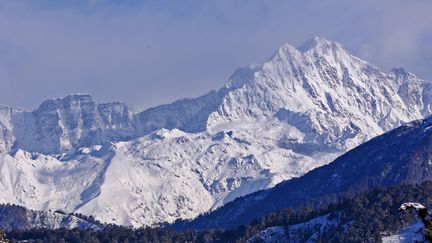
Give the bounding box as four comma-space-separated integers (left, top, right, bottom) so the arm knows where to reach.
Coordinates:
0, 38, 432, 226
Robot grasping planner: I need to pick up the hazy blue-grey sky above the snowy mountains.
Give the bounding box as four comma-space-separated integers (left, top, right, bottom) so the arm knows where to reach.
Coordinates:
0, 0, 432, 111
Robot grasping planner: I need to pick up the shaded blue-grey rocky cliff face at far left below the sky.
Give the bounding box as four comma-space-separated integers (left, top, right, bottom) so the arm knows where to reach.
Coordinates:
1, 95, 136, 154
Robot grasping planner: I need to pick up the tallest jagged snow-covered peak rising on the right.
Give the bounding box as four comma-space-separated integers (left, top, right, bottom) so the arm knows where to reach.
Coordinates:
207, 37, 430, 149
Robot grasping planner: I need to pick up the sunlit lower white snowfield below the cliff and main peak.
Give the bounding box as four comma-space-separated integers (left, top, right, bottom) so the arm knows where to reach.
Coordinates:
0, 121, 331, 226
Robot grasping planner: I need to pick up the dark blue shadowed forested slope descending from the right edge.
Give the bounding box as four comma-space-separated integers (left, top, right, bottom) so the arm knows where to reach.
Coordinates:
181, 117, 432, 229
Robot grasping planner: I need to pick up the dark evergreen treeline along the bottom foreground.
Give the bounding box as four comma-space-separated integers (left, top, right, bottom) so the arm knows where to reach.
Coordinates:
7, 182, 432, 242
